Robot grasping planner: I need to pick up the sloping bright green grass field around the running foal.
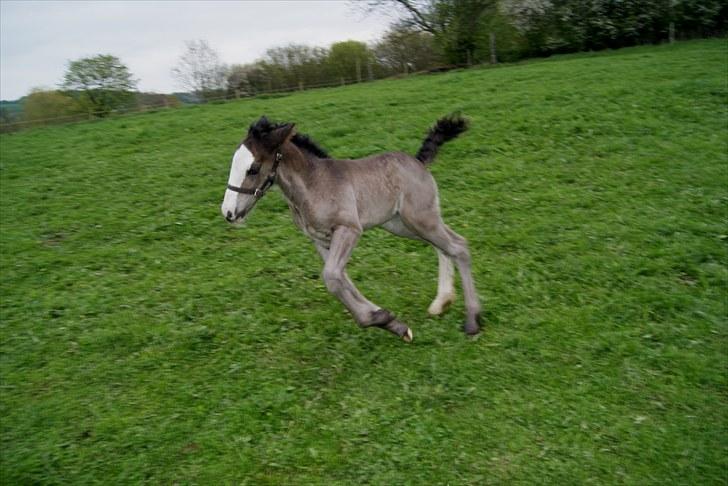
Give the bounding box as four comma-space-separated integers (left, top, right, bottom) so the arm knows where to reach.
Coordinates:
0, 39, 728, 485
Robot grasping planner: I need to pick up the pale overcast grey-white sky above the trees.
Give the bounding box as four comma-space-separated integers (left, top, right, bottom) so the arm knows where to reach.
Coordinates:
0, 0, 393, 100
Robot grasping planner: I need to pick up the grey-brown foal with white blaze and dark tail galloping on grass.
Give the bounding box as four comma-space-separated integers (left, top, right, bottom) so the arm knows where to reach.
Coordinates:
221, 115, 480, 342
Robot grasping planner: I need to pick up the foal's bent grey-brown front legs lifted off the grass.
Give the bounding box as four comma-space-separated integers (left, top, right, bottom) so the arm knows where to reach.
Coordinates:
316, 226, 412, 342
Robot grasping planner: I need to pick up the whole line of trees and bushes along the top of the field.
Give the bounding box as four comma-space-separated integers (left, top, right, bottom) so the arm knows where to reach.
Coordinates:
0, 0, 728, 131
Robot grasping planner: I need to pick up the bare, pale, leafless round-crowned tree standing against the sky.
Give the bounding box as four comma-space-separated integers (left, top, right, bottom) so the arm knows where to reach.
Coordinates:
172, 40, 227, 100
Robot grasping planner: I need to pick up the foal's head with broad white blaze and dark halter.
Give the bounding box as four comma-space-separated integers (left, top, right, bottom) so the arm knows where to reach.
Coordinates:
220, 117, 294, 224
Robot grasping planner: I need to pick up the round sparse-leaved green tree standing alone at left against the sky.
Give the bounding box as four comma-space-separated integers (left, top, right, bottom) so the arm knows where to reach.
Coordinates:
61, 54, 136, 116
